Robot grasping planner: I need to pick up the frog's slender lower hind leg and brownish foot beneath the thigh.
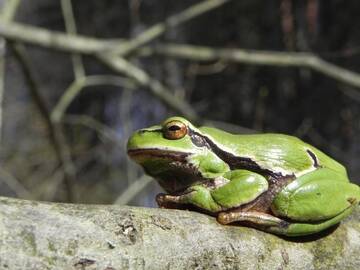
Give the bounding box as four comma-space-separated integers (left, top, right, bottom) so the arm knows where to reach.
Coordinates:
218, 201, 357, 236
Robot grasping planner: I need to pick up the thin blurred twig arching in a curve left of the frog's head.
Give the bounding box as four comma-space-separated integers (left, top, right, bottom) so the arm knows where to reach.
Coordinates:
51, 75, 136, 123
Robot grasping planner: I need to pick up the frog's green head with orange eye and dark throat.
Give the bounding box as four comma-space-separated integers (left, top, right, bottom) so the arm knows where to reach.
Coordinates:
127, 117, 229, 193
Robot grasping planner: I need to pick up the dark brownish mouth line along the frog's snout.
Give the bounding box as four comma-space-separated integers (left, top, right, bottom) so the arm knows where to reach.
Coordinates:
128, 148, 190, 161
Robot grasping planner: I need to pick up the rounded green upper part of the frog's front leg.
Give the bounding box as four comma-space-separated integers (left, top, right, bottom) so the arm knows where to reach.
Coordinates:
211, 170, 268, 209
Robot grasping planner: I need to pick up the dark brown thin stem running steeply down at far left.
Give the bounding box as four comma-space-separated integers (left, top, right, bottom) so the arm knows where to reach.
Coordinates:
11, 44, 76, 202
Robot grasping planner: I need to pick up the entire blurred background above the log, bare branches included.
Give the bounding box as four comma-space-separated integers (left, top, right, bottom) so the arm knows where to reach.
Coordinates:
0, 0, 360, 206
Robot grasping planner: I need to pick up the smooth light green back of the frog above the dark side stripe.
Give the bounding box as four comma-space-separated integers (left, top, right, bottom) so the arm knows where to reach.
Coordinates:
200, 127, 346, 176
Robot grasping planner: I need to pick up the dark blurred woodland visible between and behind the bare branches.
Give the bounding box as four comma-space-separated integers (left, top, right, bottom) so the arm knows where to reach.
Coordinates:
0, 0, 360, 206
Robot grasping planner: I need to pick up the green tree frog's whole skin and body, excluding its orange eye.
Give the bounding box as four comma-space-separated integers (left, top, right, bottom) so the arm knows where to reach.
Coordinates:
127, 117, 360, 236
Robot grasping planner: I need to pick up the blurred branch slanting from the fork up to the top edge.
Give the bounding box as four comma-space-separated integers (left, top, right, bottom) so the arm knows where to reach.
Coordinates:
108, 0, 230, 56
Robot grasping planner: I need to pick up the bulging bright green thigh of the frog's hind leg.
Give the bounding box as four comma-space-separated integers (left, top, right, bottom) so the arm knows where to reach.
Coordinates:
271, 168, 360, 221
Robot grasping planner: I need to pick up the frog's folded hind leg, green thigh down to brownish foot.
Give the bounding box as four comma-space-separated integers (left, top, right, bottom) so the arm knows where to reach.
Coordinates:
218, 168, 360, 236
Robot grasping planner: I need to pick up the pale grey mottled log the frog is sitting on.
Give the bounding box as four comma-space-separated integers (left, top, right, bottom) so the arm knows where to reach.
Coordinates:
0, 197, 360, 270
